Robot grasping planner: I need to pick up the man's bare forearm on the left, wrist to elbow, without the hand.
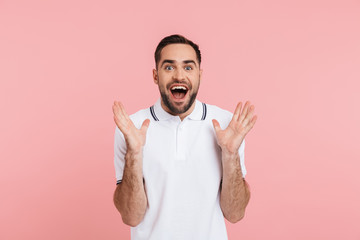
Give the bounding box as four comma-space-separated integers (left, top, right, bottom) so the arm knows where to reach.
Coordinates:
114, 153, 147, 227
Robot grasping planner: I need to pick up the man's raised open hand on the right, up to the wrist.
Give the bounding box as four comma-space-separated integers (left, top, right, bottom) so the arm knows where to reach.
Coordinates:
212, 101, 257, 155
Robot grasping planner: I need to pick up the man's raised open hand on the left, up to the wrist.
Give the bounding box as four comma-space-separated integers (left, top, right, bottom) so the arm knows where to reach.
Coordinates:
113, 101, 150, 153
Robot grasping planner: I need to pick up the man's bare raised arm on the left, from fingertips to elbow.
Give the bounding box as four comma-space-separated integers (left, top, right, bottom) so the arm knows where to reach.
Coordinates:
113, 102, 150, 227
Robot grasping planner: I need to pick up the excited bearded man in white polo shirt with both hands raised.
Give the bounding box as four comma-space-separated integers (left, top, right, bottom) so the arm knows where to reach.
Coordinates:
113, 35, 257, 240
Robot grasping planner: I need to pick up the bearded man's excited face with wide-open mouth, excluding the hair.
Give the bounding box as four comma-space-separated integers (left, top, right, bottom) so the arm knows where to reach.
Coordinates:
153, 44, 202, 115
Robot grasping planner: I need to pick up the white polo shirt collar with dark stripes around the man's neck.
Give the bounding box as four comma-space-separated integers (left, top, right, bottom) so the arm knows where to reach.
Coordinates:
150, 98, 207, 121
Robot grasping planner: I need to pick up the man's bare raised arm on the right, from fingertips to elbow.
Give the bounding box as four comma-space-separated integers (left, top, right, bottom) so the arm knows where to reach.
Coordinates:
213, 102, 257, 223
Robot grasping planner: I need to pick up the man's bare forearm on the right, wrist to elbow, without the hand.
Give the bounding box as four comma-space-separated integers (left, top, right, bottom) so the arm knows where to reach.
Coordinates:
220, 153, 250, 223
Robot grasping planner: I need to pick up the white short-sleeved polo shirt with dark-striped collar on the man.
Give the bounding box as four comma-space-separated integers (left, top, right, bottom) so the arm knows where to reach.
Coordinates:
114, 99, 246, 240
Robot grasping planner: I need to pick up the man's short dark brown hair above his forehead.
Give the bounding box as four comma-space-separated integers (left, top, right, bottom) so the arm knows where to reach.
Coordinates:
155, 34, 201, 68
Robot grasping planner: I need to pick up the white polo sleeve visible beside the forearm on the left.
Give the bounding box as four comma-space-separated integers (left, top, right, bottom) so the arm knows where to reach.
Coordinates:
114, 127, 126, 184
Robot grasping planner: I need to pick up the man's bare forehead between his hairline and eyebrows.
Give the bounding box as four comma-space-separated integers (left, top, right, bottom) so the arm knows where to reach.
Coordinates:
160, 43, 197, 62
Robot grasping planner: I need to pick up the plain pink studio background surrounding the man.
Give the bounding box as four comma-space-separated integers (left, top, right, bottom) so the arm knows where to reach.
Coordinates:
0, 0, 360, 240
